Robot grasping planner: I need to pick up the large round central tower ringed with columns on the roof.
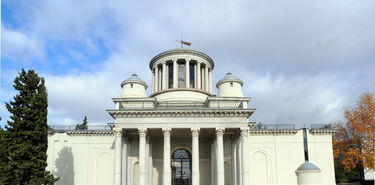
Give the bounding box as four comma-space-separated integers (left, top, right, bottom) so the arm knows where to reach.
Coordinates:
150, 48, 214, 102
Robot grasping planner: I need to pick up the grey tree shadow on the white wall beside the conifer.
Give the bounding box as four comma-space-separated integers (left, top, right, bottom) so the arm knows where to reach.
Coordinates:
54, 147, 74, 185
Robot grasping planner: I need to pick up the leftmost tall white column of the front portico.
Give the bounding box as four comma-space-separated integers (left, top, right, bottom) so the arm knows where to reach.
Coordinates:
113, 128, 122, 185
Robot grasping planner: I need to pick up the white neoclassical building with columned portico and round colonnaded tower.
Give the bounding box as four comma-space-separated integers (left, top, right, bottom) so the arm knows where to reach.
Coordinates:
48, 49, 335, 185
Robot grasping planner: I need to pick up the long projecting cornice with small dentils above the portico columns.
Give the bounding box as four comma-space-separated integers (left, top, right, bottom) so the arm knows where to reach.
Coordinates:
107, 109, 255, 118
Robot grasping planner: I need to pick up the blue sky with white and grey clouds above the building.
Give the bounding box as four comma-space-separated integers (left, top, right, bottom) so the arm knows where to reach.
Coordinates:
0, 0, 375, 126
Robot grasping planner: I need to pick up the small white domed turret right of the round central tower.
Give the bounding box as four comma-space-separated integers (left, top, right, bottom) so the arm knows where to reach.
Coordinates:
216, 72, 243, 97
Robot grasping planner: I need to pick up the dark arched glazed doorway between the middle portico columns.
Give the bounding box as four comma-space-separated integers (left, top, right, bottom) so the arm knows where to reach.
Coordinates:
171, 149, 192, 185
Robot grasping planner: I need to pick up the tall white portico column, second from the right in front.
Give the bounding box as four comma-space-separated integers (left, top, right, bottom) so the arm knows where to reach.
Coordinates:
216, 128, 225, 185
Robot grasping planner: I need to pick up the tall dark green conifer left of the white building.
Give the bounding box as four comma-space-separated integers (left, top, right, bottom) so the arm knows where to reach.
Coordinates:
0, 69, 58, 184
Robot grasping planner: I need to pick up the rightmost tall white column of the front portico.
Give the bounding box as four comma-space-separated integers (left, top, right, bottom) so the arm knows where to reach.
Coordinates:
241, 127, 249, 184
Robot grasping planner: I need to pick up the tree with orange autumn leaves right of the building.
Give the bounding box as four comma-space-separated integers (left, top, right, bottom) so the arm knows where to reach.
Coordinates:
333, 93, 375, 180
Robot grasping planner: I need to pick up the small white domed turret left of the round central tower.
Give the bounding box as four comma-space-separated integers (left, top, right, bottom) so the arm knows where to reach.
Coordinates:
121, 74, 147, 98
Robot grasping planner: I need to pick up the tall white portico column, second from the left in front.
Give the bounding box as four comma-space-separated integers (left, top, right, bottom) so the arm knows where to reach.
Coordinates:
138, 128, 147, 185
